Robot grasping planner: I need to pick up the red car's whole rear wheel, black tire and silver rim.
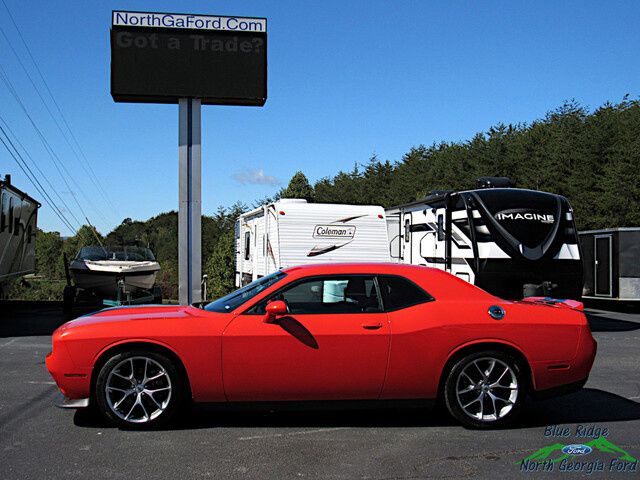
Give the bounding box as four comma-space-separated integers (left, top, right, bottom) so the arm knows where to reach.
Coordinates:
444, 350, 528, 429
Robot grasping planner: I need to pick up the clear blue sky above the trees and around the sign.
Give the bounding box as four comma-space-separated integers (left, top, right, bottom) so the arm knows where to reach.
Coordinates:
0, 0, 640, 235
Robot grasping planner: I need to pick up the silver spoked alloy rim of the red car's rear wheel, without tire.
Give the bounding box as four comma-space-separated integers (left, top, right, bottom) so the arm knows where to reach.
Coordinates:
456, 357, 518, 422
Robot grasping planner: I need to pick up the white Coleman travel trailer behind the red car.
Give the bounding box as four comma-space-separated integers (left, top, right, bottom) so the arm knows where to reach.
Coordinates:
235, 199, 390, 287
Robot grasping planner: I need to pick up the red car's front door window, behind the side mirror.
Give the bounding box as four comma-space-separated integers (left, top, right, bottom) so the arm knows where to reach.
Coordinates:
248, 275, 381, 315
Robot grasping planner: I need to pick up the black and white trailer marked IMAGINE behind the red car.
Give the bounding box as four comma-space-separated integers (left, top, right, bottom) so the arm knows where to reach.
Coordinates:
386, 177, 582, 299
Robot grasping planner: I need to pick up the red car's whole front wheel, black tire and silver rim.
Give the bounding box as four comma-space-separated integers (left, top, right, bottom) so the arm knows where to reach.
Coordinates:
94, 349, 184, 429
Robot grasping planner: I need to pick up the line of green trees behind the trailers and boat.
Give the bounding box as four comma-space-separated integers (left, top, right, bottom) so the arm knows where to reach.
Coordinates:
11, 97, 640, 299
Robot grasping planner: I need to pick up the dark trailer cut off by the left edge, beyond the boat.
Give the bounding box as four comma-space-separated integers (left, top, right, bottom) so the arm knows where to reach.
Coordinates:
0, 175, 40, 298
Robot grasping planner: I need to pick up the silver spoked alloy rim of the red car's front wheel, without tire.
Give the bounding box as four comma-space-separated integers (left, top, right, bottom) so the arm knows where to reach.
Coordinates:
104, 356, 171, 423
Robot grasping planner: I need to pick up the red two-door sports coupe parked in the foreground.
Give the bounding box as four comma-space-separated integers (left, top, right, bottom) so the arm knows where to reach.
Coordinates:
46, 264, 596, 428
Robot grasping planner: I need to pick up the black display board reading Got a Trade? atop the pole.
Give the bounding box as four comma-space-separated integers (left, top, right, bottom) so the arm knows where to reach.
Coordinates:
111, 11, 267, 106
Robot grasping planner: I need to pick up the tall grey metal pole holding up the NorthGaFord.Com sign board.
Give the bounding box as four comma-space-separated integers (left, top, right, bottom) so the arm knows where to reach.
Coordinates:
178, 98, 202, 305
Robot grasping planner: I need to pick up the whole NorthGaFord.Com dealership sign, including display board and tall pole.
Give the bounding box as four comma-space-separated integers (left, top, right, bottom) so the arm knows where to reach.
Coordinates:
110, 10, 267, 305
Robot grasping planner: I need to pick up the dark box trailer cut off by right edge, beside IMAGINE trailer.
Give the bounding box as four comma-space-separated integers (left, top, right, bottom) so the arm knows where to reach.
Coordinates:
579, 227, 640, 302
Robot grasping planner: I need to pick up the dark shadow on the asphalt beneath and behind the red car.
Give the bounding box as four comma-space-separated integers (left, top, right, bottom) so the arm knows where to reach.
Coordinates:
74, 388, 640, 430
